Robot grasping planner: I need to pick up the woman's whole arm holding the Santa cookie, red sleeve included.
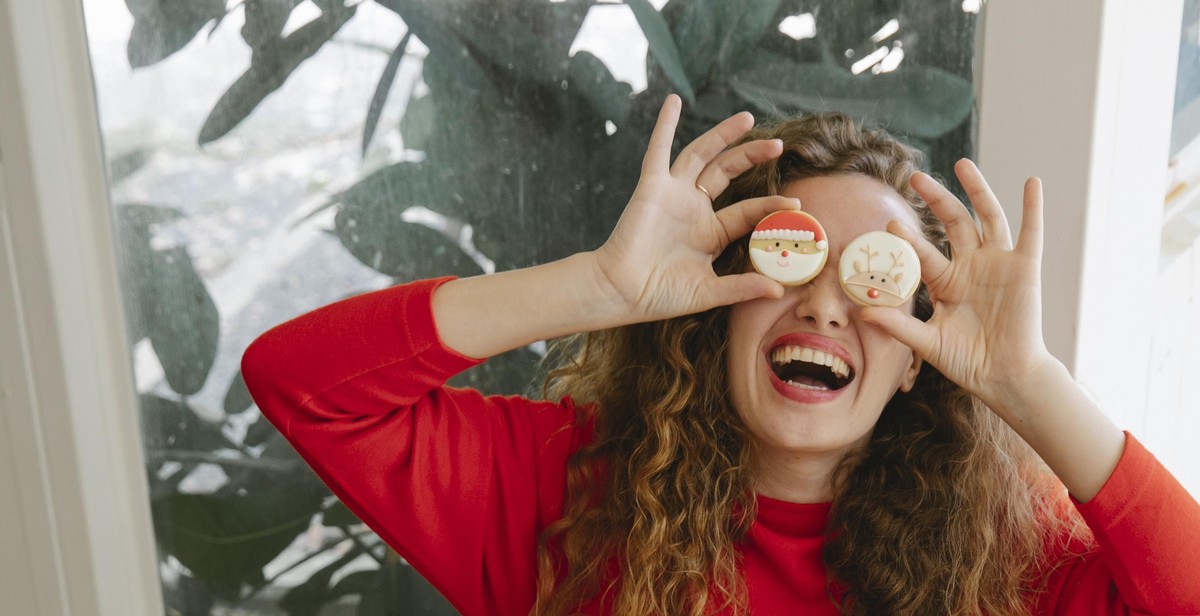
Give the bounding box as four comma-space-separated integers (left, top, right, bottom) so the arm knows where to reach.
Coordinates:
242, 96, 798, 615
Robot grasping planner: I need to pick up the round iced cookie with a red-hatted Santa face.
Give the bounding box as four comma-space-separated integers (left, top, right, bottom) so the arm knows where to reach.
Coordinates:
750, 211, 829, 286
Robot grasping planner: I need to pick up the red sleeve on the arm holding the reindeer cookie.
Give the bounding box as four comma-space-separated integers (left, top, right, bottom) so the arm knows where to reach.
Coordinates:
1034, 435, 1200, 616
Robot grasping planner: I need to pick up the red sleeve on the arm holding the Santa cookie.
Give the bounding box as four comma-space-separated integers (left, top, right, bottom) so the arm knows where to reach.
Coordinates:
242, 279, 584, 616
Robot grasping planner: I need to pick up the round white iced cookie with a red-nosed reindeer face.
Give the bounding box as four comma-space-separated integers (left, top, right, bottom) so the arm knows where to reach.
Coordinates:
838, 231, 920, 306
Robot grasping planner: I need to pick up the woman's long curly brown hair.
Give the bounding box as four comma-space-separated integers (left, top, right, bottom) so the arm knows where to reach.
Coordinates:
533, 114, 1086, 609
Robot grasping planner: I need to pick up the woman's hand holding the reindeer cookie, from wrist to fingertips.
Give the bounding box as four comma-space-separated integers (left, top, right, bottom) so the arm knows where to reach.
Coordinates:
862, 159, 1057, 411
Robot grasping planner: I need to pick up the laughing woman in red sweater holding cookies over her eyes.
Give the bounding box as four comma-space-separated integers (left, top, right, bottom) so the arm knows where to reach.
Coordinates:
244, 96, 1200, 615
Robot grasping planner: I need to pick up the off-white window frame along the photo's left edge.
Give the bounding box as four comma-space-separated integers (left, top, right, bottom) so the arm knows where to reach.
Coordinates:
0, 0, 163, 609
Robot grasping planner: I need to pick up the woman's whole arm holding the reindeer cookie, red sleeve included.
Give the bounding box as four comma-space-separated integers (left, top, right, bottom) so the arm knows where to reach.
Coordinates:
862, 160, 1200, 614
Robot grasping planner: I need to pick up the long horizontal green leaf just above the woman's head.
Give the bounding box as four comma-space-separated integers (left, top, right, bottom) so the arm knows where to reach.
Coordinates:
732, 52, 974, 139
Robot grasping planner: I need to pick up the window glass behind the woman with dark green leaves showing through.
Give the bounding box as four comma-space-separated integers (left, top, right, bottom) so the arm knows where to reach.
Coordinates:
84, 0, 982, 615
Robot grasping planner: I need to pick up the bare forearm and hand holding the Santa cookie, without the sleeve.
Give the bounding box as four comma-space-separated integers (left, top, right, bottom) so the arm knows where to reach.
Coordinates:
434, 95, 799, 358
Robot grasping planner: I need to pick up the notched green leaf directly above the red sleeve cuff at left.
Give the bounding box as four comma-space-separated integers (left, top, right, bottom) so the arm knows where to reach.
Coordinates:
334, 162, 481, 280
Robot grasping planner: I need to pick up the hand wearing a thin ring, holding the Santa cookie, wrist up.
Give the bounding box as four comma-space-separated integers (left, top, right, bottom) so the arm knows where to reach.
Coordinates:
593, 95, 800, 322
